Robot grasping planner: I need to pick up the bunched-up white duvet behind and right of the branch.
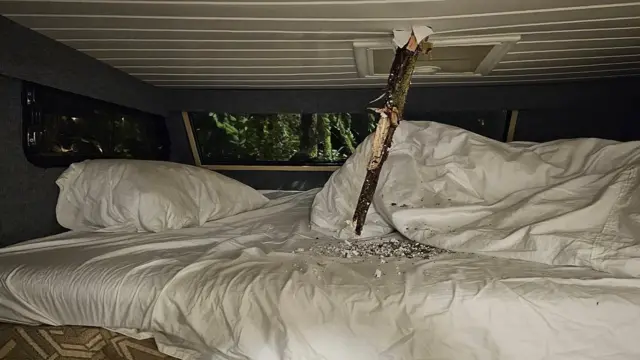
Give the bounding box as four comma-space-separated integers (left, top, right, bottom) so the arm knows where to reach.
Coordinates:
311, 122, 640, 277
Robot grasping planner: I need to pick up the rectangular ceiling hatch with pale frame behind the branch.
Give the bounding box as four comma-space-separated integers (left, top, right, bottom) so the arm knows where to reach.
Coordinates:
353, 35, 520, 78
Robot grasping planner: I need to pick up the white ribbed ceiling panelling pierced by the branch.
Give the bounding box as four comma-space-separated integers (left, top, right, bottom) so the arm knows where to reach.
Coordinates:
0, 0, 640, 88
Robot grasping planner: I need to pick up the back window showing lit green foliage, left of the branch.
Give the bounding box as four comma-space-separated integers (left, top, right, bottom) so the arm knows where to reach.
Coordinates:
190, 112, 376, 165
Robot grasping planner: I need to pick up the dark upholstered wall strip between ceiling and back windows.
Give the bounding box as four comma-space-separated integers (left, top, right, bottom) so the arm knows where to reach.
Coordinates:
169, 77, 640, 113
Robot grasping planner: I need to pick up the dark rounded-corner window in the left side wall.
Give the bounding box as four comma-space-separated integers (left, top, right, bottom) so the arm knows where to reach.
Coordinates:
23, 82, 170, 167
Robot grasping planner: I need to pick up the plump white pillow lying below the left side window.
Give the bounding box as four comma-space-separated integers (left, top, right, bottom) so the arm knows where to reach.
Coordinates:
56, 160, 269, 232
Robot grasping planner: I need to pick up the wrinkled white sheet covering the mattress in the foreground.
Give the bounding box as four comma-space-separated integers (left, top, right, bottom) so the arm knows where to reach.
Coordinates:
0, 190, 640, 360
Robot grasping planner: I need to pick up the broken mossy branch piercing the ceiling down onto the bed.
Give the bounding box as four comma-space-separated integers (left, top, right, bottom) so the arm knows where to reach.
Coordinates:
353, 33, 431, 235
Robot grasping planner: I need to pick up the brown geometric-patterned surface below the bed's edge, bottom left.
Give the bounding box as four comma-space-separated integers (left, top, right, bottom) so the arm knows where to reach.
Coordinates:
0, 324, 174, 360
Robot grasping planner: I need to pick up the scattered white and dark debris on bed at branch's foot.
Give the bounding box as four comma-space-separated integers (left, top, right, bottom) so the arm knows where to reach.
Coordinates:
309, 238, 451, 264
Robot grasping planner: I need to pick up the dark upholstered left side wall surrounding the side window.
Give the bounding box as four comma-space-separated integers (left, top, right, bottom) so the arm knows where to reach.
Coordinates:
0, 16, 166, 246
